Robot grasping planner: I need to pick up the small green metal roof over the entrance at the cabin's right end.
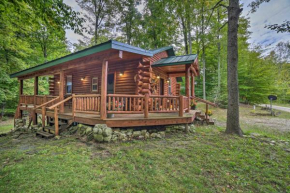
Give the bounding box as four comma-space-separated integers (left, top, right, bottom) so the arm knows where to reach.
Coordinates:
152, 54, 197, 67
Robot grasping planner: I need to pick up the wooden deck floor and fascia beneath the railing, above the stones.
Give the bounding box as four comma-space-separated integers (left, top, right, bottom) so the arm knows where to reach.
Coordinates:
20, 106, 199, 127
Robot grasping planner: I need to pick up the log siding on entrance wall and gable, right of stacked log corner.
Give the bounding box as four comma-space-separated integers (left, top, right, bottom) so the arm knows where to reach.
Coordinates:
143, 51, 176, 95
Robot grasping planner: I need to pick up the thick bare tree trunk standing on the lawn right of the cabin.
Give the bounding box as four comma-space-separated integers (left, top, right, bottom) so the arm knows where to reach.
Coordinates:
226, 0, 242, 136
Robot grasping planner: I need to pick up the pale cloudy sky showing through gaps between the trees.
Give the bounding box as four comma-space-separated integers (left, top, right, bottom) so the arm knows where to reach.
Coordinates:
64, 0, 290, 50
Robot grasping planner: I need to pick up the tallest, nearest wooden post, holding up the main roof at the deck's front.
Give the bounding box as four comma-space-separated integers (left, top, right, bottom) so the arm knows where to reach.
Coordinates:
100, 59, 108, 119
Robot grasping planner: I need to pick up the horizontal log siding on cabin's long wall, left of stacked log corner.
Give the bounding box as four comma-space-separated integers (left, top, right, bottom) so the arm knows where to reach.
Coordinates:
54, 58, 141, 95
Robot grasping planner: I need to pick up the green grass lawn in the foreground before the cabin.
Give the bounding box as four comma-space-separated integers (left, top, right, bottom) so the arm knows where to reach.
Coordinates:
0, 107, 290, 192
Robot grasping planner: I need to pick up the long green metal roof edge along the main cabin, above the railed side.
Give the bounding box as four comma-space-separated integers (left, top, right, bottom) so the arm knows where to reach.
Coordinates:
10, 40, 175, 78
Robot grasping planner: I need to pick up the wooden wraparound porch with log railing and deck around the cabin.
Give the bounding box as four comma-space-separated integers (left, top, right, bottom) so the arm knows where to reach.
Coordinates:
19, 94, 204, 127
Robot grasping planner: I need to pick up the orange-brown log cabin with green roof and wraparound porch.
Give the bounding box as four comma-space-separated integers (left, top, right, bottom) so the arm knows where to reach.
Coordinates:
10, 40, 214, 135
